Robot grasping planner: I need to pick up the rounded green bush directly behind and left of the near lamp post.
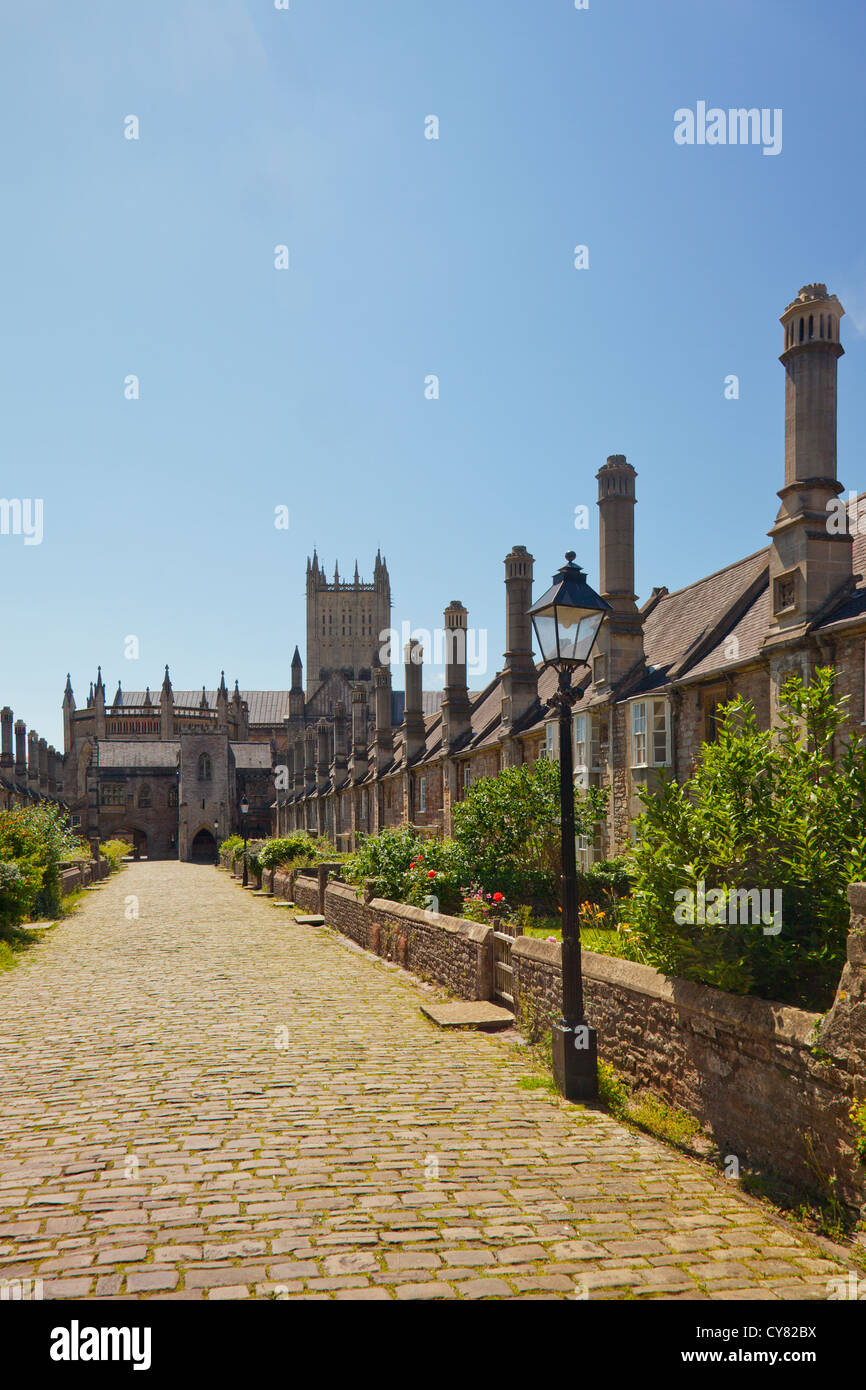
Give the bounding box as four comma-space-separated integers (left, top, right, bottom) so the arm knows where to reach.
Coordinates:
453, 758, 607, 901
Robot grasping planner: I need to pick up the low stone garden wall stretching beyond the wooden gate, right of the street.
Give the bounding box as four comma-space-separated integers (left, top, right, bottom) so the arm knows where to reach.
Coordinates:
275, 870, 493, 999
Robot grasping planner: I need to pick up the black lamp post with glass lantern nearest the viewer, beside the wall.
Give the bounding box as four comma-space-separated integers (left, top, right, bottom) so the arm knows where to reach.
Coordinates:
530, 550, 610, 1101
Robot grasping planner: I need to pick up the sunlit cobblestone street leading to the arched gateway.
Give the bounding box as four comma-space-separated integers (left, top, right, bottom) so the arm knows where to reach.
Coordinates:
0, 863, 842, 1300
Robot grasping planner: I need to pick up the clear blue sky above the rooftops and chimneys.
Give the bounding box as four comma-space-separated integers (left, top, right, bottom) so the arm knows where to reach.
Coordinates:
0, 0, 866, 744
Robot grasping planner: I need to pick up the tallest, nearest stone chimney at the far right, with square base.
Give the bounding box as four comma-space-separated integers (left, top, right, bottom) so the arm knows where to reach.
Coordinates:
767, 284, 853, 645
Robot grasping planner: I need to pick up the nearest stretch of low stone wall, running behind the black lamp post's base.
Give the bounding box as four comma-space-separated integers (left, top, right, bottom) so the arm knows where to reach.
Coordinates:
512, 906, 866, 1207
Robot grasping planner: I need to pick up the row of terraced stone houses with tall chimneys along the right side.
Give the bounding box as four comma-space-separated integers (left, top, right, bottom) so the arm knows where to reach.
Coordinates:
283, 285, 866, 865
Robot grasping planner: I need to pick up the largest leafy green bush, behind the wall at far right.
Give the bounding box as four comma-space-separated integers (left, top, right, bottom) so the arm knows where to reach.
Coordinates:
628, 669, 866, 1008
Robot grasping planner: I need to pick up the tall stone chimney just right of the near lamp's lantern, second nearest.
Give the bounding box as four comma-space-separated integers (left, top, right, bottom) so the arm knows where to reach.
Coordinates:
592, 453, 644, 687
